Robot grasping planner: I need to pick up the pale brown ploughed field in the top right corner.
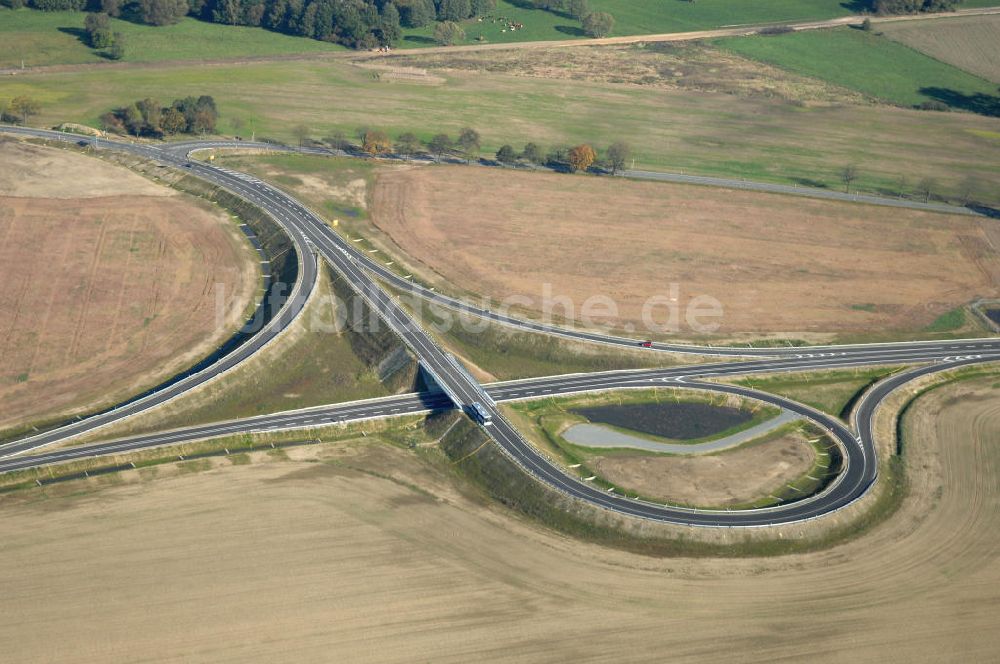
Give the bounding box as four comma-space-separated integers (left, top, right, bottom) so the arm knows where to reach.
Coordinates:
879, 15, 1000, 83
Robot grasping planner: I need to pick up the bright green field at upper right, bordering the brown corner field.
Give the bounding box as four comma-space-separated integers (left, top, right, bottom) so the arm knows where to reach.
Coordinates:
713, 28, 997, 108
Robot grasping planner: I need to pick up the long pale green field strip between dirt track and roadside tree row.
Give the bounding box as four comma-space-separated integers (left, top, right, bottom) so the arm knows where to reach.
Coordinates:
0, 54, 1000, 202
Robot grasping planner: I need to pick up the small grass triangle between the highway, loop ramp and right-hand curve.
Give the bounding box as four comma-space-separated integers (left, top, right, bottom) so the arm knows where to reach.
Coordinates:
723, 367, 901, 419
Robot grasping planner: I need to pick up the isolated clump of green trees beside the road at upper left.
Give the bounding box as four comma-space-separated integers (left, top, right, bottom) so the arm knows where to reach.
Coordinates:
101, 95, 219, 138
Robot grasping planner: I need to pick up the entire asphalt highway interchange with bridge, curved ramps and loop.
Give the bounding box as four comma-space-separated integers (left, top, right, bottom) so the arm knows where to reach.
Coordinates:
0, 127, 1000, 527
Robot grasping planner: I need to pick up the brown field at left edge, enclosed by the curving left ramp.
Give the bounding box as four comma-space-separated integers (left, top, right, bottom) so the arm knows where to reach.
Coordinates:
0, 142, 259, 428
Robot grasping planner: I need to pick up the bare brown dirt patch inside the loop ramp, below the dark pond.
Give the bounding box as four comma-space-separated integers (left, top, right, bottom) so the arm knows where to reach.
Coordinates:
587, 433, 816, 507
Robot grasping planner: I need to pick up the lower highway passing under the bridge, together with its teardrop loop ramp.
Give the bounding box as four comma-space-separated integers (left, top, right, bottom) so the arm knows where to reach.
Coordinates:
0, 353, 1000, 526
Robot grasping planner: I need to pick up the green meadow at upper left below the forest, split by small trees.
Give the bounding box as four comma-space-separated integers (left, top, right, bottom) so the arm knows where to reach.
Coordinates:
0, 8, 344, 68
